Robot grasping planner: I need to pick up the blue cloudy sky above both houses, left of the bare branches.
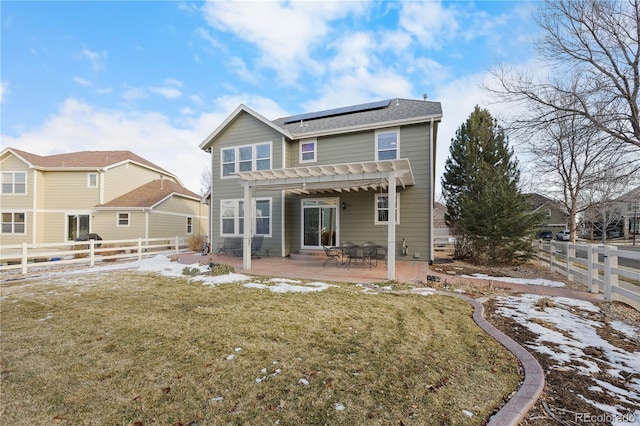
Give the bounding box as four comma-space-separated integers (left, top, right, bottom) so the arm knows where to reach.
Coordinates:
0, 1, 538, 192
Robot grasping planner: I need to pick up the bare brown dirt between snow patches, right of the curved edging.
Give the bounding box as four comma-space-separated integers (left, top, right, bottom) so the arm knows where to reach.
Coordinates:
432, 260, 640, 426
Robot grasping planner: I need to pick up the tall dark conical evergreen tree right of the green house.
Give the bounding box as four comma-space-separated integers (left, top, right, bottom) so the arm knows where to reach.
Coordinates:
442, 106, 539, 262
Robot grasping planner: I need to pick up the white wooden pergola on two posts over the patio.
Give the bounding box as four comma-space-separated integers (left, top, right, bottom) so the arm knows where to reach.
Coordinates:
235, 158, 415, 280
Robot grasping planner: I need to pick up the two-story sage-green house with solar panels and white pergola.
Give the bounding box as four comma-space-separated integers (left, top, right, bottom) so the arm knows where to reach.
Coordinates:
200, 99, 442, 279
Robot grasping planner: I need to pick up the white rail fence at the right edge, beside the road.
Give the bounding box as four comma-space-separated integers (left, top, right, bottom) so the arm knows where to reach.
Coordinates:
535, 241, 640, 310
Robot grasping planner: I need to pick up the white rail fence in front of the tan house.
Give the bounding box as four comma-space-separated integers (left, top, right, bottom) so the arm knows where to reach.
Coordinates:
0, 237, 189, 274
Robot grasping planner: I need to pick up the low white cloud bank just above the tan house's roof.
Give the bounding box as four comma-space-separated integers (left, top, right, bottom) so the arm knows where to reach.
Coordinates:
2, 99, 212, 192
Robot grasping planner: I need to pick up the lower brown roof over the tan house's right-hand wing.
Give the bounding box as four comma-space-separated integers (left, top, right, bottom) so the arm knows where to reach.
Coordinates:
96, 179, 200, 209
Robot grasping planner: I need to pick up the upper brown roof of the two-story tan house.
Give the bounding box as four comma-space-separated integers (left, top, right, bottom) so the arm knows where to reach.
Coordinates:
7, 148, 175, 177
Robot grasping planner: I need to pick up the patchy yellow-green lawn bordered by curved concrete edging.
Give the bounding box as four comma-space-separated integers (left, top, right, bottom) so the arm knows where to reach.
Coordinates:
0, 271, 519, 425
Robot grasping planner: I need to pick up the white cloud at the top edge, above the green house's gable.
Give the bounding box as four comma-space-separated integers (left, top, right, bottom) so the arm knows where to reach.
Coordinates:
202, 1, 368, 85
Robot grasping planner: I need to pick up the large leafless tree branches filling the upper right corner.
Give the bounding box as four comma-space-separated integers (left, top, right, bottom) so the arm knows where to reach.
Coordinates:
490, 0, 640, 148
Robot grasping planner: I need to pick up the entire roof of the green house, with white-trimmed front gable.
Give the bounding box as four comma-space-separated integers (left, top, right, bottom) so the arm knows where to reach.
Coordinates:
200, 98, 442, 151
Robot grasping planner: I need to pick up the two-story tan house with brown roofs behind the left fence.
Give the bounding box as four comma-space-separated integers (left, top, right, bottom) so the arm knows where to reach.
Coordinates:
0, 148, 208, 245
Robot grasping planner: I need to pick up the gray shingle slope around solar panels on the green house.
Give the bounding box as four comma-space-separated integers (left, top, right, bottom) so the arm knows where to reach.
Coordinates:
273, 99, 442, 136
